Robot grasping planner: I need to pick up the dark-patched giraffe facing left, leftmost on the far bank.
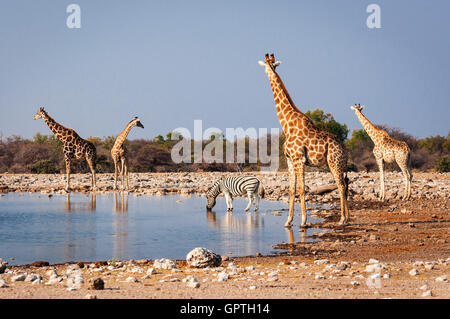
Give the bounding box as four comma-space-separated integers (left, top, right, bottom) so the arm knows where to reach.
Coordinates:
33, 107, 97, 193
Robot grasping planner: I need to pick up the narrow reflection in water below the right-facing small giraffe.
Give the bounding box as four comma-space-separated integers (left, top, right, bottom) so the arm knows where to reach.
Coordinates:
112, 192, 128, 259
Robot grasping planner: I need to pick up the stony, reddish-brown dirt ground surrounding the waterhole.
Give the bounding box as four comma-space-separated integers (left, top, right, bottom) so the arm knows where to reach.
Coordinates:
0, 172, 450, 299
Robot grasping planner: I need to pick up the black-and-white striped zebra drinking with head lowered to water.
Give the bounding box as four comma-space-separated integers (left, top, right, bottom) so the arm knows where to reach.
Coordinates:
206, 176, 264, 212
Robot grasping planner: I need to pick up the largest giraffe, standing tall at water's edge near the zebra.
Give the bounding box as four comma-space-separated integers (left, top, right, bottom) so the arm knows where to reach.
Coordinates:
259, 54, 350, 228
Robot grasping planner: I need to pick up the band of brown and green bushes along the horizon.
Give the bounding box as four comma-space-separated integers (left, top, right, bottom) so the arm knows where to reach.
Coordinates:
0, 109, 450, 174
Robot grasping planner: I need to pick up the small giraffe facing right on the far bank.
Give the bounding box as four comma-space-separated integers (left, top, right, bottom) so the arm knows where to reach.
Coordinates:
111, 116, 144, 189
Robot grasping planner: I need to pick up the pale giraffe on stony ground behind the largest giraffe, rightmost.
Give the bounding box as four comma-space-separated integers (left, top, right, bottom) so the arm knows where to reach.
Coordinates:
350, 104, 412, 201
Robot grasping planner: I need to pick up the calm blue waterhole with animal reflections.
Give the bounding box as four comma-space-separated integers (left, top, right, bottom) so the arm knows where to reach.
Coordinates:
0, 193, 326, 264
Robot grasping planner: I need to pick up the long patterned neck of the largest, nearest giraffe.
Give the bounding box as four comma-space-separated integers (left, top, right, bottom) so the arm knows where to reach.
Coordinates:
266, 69, 310, 135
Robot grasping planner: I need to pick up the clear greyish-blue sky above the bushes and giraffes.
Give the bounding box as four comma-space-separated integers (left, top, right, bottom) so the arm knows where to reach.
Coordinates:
0, 0, 450, 139
